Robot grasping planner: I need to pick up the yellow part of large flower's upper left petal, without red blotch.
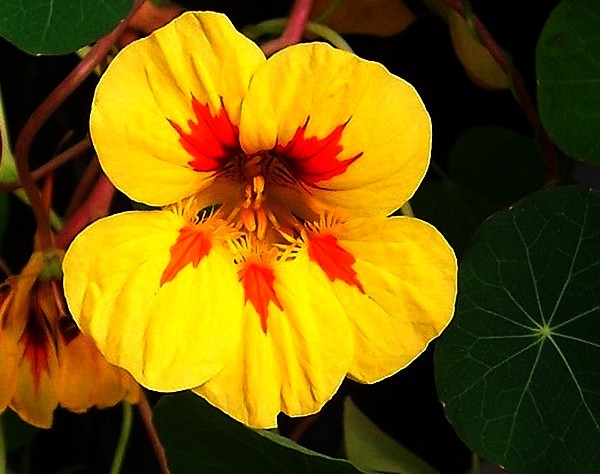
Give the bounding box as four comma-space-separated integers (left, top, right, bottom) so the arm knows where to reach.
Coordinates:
90, 12, 265, 205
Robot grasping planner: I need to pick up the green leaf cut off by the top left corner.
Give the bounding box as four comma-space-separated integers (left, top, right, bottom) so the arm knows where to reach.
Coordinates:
0, 0, 133, 54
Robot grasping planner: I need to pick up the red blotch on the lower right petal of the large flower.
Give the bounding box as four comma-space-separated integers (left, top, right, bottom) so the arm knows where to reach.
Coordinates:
308, 234, 365, 293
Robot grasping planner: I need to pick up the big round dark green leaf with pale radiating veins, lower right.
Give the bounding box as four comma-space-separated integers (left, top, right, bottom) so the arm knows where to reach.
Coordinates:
435, 187, 600, 474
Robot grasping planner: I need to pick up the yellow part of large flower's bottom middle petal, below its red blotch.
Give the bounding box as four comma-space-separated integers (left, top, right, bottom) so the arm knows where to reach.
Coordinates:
195, 252, 353, 428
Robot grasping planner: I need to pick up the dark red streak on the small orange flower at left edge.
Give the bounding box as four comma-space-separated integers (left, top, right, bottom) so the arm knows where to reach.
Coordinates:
21, 301, 51, 391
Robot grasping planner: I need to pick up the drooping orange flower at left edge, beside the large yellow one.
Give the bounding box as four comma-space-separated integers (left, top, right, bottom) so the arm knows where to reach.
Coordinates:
0, 252, 139, 428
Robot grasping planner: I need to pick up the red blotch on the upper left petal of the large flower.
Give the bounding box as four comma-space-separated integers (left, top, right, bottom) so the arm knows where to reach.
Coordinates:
169, 97, 240, 172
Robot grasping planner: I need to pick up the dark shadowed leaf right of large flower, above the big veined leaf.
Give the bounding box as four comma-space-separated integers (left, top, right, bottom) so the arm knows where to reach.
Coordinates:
411, 127, 546, 255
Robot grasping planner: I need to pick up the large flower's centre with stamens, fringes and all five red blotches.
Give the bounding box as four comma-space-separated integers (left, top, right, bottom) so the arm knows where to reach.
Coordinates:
160, 99, 364, 334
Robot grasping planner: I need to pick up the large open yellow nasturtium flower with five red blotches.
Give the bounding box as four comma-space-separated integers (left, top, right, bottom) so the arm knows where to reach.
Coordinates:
63, 13, 456, 427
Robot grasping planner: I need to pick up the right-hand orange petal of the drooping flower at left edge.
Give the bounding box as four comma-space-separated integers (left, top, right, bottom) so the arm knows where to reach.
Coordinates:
58, 328, 137, 412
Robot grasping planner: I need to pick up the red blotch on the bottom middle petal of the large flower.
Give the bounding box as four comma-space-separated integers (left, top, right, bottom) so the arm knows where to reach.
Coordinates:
238, 262, 283, 334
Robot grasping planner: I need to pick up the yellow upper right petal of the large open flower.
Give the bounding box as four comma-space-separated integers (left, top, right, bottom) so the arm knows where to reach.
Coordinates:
240, 43, 431, 215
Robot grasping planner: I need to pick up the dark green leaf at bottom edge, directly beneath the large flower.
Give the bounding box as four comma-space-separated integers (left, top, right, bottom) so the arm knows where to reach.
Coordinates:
154, 392, 361, 474
